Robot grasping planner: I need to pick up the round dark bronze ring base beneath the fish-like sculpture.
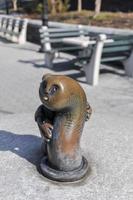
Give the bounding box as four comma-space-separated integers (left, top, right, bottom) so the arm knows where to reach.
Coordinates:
40, 156, 89, 182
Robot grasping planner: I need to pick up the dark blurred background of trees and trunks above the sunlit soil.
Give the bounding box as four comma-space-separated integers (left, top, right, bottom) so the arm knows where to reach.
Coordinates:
0, 0, 133, 14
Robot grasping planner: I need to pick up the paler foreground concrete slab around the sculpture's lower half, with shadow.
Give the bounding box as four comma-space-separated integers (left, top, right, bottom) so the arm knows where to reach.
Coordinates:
0, 113, 133, 200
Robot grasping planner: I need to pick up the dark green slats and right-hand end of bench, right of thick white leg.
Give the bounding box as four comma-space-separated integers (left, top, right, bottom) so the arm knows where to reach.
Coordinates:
101, 35, 133, 77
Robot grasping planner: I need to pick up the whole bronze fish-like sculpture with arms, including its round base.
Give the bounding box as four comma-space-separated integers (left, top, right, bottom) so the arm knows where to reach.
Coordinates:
35, 74, 91, 181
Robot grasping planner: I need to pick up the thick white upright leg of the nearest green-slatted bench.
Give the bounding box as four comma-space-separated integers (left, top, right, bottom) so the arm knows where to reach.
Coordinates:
83, 34, 107, 86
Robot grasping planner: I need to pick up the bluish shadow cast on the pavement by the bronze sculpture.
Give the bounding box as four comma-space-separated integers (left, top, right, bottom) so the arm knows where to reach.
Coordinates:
0, 130, 43, 168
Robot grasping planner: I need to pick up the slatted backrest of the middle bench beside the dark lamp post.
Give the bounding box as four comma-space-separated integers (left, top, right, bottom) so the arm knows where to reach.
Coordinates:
39, 25, 91, 51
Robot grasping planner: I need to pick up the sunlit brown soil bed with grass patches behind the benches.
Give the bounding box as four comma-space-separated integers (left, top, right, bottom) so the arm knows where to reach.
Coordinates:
26, 10, 133, 29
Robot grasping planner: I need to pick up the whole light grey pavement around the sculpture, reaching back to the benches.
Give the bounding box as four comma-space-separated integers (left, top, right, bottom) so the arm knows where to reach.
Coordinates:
0, 38, 133, 200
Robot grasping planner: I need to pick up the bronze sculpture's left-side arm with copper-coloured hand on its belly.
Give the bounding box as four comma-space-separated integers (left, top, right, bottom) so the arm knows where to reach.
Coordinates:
35, 105, 53, 142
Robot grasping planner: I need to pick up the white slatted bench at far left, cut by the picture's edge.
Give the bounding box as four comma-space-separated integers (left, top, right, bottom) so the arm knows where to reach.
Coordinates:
0, 16, 28, 44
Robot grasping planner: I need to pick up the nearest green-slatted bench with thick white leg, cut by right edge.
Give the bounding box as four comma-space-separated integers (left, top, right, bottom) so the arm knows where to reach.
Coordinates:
74, 35, 133, 85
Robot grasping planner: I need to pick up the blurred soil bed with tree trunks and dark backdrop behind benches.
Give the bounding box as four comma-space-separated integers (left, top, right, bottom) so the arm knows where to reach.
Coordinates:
0, 0, 133, 29
